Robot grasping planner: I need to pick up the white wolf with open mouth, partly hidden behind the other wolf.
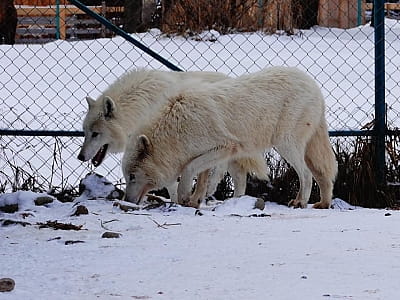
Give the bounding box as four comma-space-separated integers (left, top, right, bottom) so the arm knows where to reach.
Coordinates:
78, 69, 267, 198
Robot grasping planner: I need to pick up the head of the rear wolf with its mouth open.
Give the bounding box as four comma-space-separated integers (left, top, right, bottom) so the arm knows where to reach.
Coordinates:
78, 96, 126, 167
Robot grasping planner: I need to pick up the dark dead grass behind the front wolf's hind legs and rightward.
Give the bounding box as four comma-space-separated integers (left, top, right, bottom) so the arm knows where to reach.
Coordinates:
242, 136, 400, 208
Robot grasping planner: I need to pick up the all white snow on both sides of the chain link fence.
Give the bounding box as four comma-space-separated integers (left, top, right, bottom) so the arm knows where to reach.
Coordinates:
0, 20, 400, 300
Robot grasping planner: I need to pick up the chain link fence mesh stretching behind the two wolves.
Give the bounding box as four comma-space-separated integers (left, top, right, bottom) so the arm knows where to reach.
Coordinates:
0, 0, 400, 202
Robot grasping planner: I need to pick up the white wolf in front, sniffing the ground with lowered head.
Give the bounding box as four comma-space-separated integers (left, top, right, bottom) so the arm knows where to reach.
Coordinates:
122, 67, 337, 208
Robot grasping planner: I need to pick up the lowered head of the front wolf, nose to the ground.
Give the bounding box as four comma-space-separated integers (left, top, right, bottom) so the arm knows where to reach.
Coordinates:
122, 135, 168, 203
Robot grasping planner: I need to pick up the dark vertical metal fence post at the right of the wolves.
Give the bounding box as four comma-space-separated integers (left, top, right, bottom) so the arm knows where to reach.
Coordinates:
374, 0, 386, 186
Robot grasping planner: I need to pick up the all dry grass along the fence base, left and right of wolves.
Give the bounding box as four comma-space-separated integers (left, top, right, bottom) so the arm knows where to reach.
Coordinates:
0, 136, 400, 208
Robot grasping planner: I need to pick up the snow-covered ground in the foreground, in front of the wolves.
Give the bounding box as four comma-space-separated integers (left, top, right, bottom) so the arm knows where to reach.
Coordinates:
0, 179, 400, 300
